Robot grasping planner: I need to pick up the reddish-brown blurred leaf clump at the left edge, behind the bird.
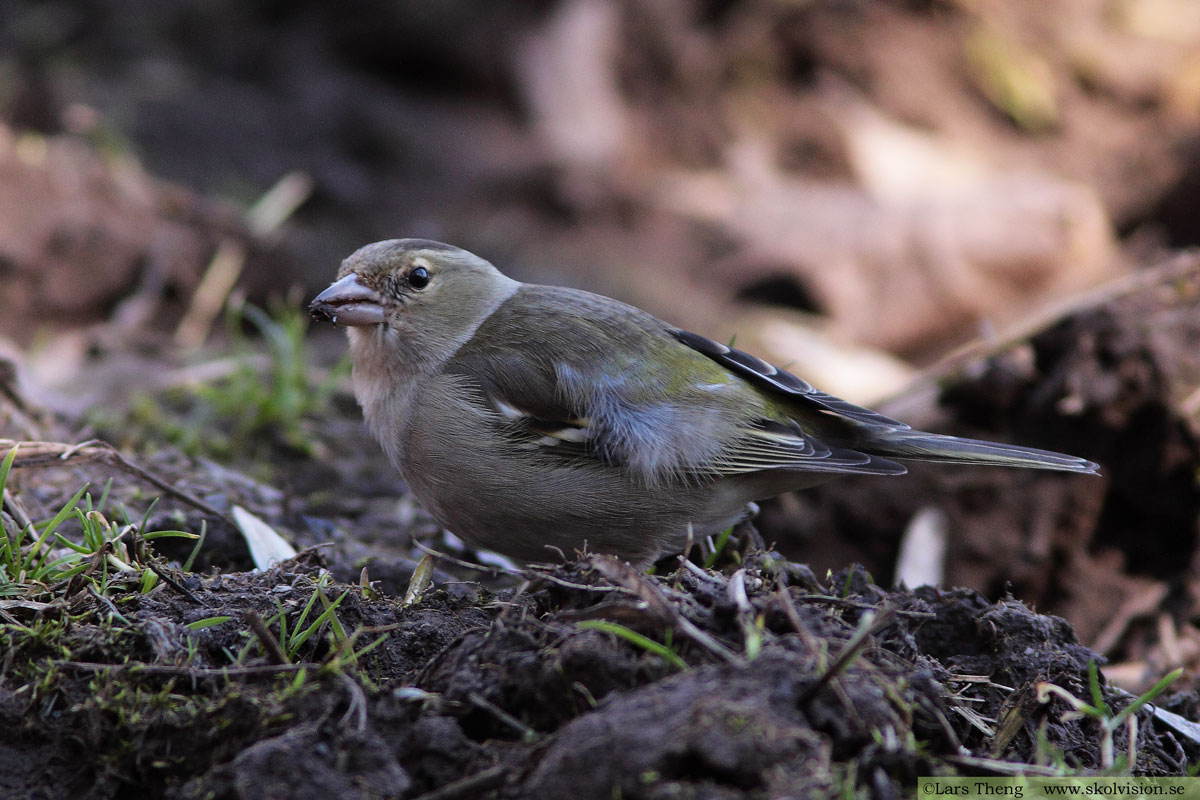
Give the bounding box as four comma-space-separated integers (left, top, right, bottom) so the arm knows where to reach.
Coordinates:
0, 126, 236, 343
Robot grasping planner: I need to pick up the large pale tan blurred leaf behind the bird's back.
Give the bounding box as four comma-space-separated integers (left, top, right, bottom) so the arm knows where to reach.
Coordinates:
649, 114, 1114, 350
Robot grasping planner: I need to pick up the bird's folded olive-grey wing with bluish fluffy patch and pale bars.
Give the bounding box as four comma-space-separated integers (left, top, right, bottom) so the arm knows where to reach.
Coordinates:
446, 287, 904, 485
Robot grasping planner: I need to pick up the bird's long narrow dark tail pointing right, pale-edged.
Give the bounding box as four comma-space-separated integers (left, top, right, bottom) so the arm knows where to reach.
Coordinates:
869, 429, 1099, 475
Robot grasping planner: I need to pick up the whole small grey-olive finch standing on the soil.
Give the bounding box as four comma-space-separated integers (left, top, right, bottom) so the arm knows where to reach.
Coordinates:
310, 239, 1097, 566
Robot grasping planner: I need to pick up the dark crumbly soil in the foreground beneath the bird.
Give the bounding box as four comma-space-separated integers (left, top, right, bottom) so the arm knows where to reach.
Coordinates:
0, 554, 1200, 799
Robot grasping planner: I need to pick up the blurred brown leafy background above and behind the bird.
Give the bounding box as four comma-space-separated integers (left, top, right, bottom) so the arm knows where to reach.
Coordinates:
11, 0, 1200, 367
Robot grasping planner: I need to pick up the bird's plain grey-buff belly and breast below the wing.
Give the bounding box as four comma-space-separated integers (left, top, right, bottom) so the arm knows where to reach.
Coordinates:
398, 375, 756, 566
